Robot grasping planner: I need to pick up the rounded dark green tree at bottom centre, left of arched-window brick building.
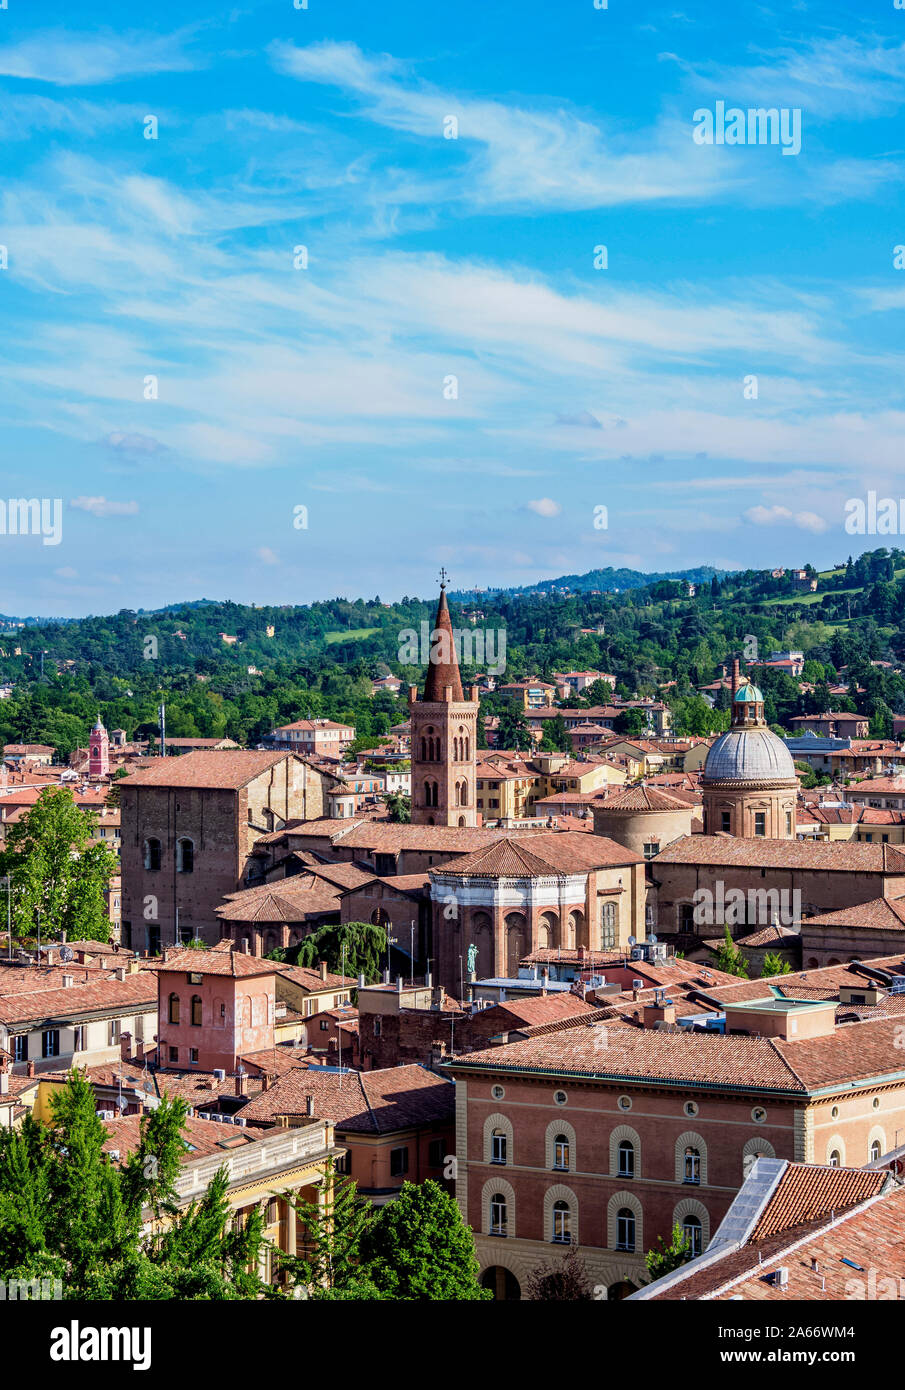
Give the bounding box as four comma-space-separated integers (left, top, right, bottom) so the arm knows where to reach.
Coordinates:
360, 1179, 491, 1302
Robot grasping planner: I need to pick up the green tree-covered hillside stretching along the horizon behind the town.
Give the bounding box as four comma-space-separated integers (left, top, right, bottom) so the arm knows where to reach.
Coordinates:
0, 549, 905, 755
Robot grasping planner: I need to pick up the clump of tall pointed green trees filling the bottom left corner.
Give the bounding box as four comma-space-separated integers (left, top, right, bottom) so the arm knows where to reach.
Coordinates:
0, 1070, 274, 1300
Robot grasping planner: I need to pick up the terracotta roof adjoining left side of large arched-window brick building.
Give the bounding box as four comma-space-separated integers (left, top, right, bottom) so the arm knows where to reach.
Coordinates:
242, 1065, 455, 1134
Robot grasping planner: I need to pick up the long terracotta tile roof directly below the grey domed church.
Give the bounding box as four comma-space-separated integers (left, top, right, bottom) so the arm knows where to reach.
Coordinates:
653, 835, 905, 874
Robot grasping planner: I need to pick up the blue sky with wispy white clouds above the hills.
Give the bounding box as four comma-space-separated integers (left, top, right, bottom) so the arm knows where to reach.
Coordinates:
0, 0, 905, 614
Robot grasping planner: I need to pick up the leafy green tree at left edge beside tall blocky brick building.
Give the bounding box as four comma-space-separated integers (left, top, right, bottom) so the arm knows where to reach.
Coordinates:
0, 787, 120, 941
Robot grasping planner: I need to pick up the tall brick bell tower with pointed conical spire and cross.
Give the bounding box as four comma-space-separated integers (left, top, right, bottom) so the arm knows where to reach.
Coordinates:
409, 570, 478, 826
